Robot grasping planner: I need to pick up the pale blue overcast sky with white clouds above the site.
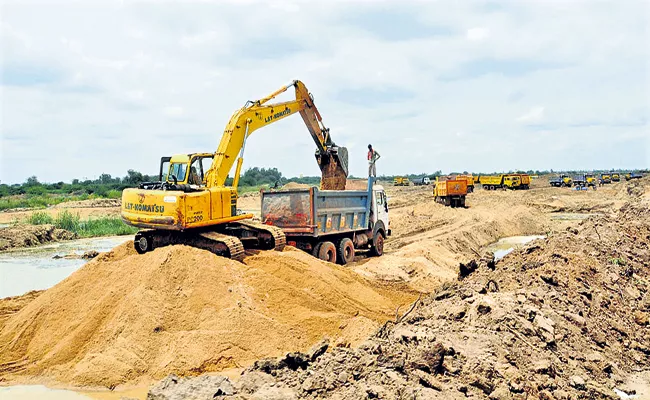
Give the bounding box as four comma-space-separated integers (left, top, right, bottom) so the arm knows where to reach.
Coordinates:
0, 0, 650, 183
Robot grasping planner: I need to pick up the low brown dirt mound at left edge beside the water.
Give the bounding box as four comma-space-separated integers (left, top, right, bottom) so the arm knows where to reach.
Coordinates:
0, 225, 77, 251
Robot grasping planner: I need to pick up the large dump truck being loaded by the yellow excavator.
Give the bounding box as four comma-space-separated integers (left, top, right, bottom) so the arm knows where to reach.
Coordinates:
261, 178, 391, 265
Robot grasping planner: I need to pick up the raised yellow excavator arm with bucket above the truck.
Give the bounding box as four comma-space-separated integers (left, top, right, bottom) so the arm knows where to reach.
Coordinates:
206, 80, 348, 190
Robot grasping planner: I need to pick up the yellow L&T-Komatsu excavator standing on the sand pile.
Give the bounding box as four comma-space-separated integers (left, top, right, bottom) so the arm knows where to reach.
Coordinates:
121, 80, 348, 260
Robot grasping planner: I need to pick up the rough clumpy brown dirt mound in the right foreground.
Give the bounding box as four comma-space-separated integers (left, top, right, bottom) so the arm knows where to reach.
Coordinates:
163, 202, 650, 399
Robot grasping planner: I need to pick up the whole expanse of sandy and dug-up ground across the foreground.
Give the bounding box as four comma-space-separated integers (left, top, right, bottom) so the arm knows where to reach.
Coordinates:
0, 179, 650, 399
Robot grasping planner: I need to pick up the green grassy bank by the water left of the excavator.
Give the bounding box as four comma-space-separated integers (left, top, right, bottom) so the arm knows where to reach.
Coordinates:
26, 210, 138, 238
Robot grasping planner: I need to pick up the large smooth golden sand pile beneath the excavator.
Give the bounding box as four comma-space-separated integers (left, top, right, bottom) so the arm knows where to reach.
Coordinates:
0, 243, 414, 387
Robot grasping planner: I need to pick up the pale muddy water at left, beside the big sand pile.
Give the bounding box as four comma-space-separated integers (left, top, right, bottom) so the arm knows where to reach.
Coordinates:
0, 236, 133, 298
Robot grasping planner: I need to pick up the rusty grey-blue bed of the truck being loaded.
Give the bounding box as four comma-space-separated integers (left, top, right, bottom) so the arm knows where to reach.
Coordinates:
261, 187, 372, 237
